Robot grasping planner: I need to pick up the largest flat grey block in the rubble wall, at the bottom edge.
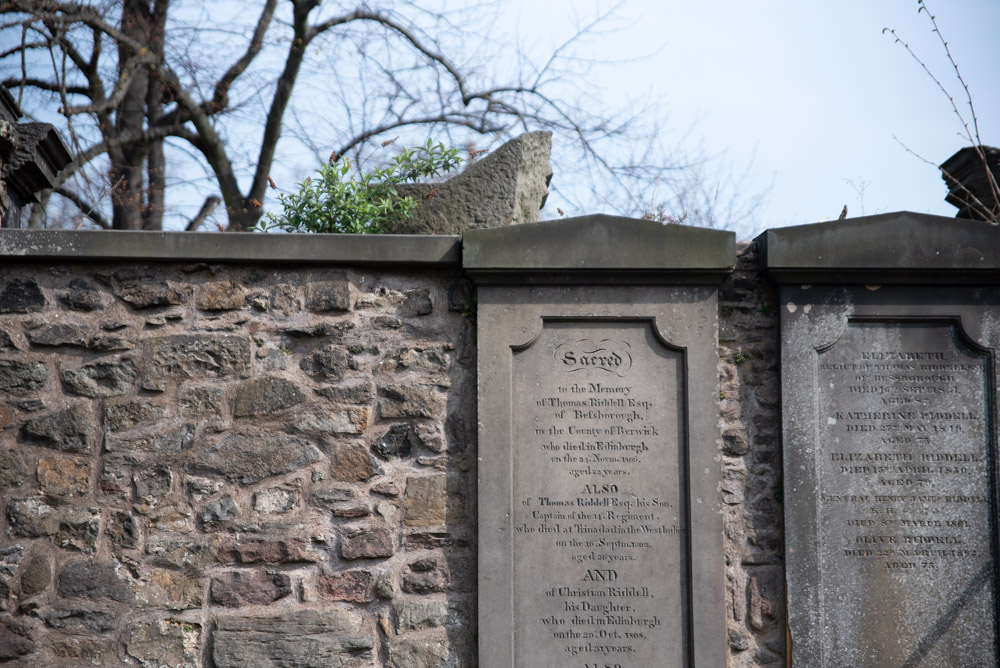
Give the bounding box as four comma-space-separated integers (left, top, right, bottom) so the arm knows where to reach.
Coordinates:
212, 608, 376, 668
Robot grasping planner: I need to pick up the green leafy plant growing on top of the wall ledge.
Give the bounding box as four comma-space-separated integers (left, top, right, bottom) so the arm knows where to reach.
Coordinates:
256, 139, 462, 234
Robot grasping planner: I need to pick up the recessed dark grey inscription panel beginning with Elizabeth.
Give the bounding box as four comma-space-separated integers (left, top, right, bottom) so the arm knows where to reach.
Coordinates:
816, 321, 997, 668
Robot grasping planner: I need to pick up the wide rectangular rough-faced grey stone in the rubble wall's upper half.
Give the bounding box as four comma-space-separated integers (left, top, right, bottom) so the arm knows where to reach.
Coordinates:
148, 334, 251, 378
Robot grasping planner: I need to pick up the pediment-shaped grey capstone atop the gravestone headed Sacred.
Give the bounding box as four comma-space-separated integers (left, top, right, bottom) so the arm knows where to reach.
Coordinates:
462, 214, 736, 284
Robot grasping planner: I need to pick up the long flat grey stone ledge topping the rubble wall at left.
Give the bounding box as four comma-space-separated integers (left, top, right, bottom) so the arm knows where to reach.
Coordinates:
0, 229, 462, 268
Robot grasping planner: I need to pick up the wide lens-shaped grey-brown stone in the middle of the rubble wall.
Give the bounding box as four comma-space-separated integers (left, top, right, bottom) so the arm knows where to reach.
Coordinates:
194, 431, 322, 485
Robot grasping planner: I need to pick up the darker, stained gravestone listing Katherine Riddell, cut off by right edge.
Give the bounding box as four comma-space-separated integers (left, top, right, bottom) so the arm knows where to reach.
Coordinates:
760, 213, 1000, 668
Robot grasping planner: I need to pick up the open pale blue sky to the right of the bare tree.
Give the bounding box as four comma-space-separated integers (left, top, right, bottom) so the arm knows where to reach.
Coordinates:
500, 0, 1000, 237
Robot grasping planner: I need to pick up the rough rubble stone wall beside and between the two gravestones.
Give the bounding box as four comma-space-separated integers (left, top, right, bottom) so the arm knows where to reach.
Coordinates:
0, 228, 786, 668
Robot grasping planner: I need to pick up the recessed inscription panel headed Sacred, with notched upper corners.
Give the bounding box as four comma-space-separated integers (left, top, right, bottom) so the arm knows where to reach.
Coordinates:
511, 321, 689, 668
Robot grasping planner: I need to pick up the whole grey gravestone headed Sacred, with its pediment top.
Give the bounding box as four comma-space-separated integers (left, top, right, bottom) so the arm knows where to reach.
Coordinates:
463, 216, 735, 668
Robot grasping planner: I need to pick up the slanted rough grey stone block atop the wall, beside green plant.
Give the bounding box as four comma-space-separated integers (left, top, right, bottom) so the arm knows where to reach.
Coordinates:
386, 132, 552, 234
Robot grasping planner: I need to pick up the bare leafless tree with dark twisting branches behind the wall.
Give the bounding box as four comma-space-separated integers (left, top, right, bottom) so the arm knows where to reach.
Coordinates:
0, 0, 753, 230
